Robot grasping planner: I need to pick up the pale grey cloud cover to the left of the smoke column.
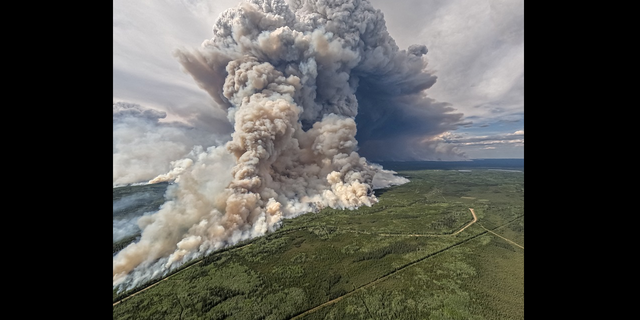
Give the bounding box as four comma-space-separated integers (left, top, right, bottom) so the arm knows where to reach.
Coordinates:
113, 0, 238, 115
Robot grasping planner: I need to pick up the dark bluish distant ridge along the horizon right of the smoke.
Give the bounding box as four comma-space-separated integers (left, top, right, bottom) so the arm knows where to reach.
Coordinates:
376, 159, 524, 171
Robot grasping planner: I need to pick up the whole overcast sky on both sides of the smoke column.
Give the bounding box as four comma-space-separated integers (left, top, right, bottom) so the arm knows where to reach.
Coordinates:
113, 0, 524, 160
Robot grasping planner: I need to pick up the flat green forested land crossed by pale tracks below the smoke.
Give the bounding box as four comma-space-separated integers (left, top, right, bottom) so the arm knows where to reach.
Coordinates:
113, 169, 524, 320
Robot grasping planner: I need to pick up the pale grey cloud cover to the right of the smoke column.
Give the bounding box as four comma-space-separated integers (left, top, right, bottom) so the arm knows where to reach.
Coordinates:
371, 0, 524, 124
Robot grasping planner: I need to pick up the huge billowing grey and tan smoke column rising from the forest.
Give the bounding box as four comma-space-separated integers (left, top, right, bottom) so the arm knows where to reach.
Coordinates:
113, 0, 461, 287
